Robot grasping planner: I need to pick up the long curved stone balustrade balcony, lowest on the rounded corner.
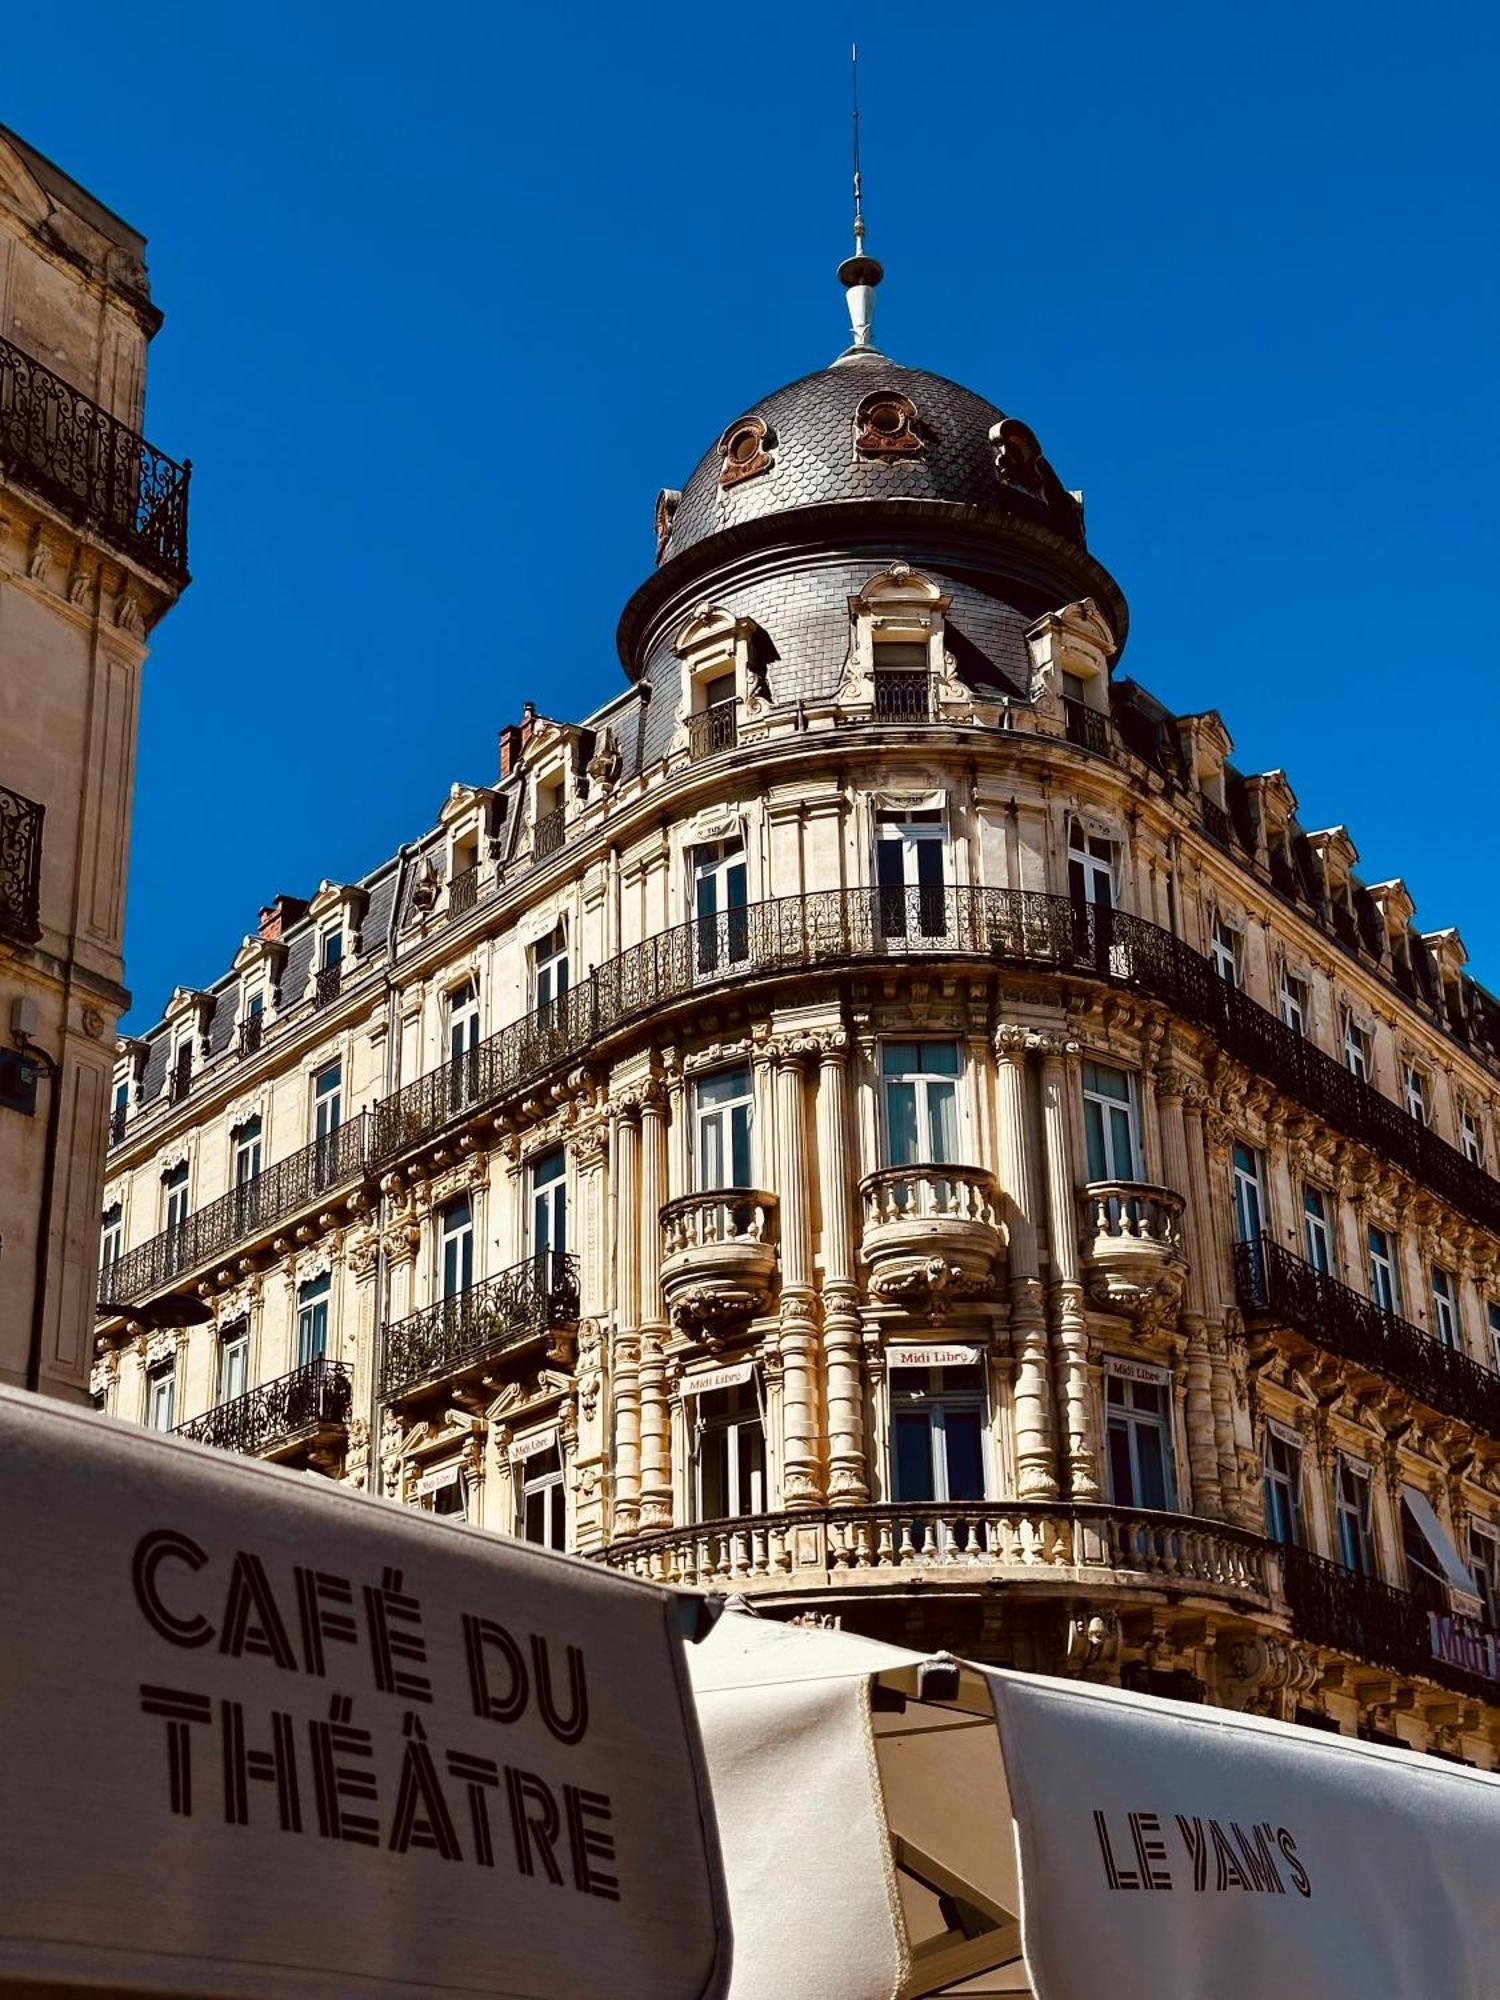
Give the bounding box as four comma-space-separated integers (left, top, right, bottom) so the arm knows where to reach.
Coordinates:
602, 1500, 1280, 1604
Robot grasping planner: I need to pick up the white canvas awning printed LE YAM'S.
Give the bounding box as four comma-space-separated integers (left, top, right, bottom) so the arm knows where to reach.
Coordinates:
690, 1616, 1500, 2000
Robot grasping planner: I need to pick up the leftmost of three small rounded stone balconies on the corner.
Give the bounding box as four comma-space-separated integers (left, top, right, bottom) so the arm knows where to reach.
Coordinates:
662, 1188, 776, 1346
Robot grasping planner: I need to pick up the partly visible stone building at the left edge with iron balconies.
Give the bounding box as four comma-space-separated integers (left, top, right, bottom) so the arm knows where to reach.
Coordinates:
0, 128, 188, 1400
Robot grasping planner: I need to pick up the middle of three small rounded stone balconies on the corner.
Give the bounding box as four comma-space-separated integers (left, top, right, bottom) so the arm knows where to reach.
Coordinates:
860, 1162, 1000, 1310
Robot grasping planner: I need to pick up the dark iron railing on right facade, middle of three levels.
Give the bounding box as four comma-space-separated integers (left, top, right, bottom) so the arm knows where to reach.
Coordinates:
1234, 1236, 1500, 1438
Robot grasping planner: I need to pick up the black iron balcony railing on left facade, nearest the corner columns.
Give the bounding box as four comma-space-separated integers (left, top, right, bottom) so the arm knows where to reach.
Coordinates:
380, 1250, 578, 1398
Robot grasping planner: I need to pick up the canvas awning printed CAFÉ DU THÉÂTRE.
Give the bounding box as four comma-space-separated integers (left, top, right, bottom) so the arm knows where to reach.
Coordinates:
0, 1390, 728, 2000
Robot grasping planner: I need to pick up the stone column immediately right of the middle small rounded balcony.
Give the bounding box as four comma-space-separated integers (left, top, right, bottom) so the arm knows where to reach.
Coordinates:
994, 1026, 1058, 1500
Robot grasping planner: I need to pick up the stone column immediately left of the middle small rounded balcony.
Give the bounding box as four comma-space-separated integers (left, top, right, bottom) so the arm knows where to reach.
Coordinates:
818, 1028, 870, 1506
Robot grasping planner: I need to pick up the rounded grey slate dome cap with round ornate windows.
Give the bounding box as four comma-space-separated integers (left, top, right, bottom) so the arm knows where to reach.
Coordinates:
658, 348, 1084, 562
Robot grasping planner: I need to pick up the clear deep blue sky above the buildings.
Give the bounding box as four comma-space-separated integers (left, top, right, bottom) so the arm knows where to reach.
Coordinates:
0, 0, 1500, 1026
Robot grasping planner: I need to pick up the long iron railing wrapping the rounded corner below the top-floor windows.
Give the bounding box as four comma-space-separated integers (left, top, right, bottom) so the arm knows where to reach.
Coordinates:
372, 886, 1500, 1232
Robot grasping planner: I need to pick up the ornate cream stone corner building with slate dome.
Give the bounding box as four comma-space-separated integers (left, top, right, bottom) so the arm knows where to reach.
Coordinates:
96, 270, 1500, 1768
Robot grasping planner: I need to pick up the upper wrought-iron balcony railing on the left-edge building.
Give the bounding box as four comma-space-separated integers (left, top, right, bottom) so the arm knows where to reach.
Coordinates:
0, 340, 192, 584
